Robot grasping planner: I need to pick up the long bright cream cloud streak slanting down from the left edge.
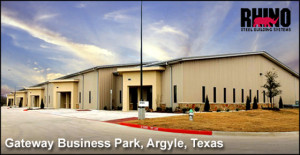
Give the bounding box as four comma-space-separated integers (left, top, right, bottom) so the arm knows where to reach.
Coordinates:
1, 7, 117, 65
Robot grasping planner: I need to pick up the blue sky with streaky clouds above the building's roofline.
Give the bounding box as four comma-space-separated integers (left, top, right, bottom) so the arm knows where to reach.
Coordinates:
1, 1, 299, 95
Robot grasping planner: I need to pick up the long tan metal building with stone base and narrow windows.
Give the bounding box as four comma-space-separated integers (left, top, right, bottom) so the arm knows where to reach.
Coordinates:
7, 51, 299, 111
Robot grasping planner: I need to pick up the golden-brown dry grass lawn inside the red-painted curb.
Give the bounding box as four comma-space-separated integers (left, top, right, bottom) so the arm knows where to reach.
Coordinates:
126, 109, 299, 132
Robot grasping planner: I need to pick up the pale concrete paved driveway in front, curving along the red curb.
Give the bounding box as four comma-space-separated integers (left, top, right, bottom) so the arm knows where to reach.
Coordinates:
1, 108, 299, 154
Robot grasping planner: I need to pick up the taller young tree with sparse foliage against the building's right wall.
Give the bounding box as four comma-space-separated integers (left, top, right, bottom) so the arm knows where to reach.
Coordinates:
262, 71, 281, 108
